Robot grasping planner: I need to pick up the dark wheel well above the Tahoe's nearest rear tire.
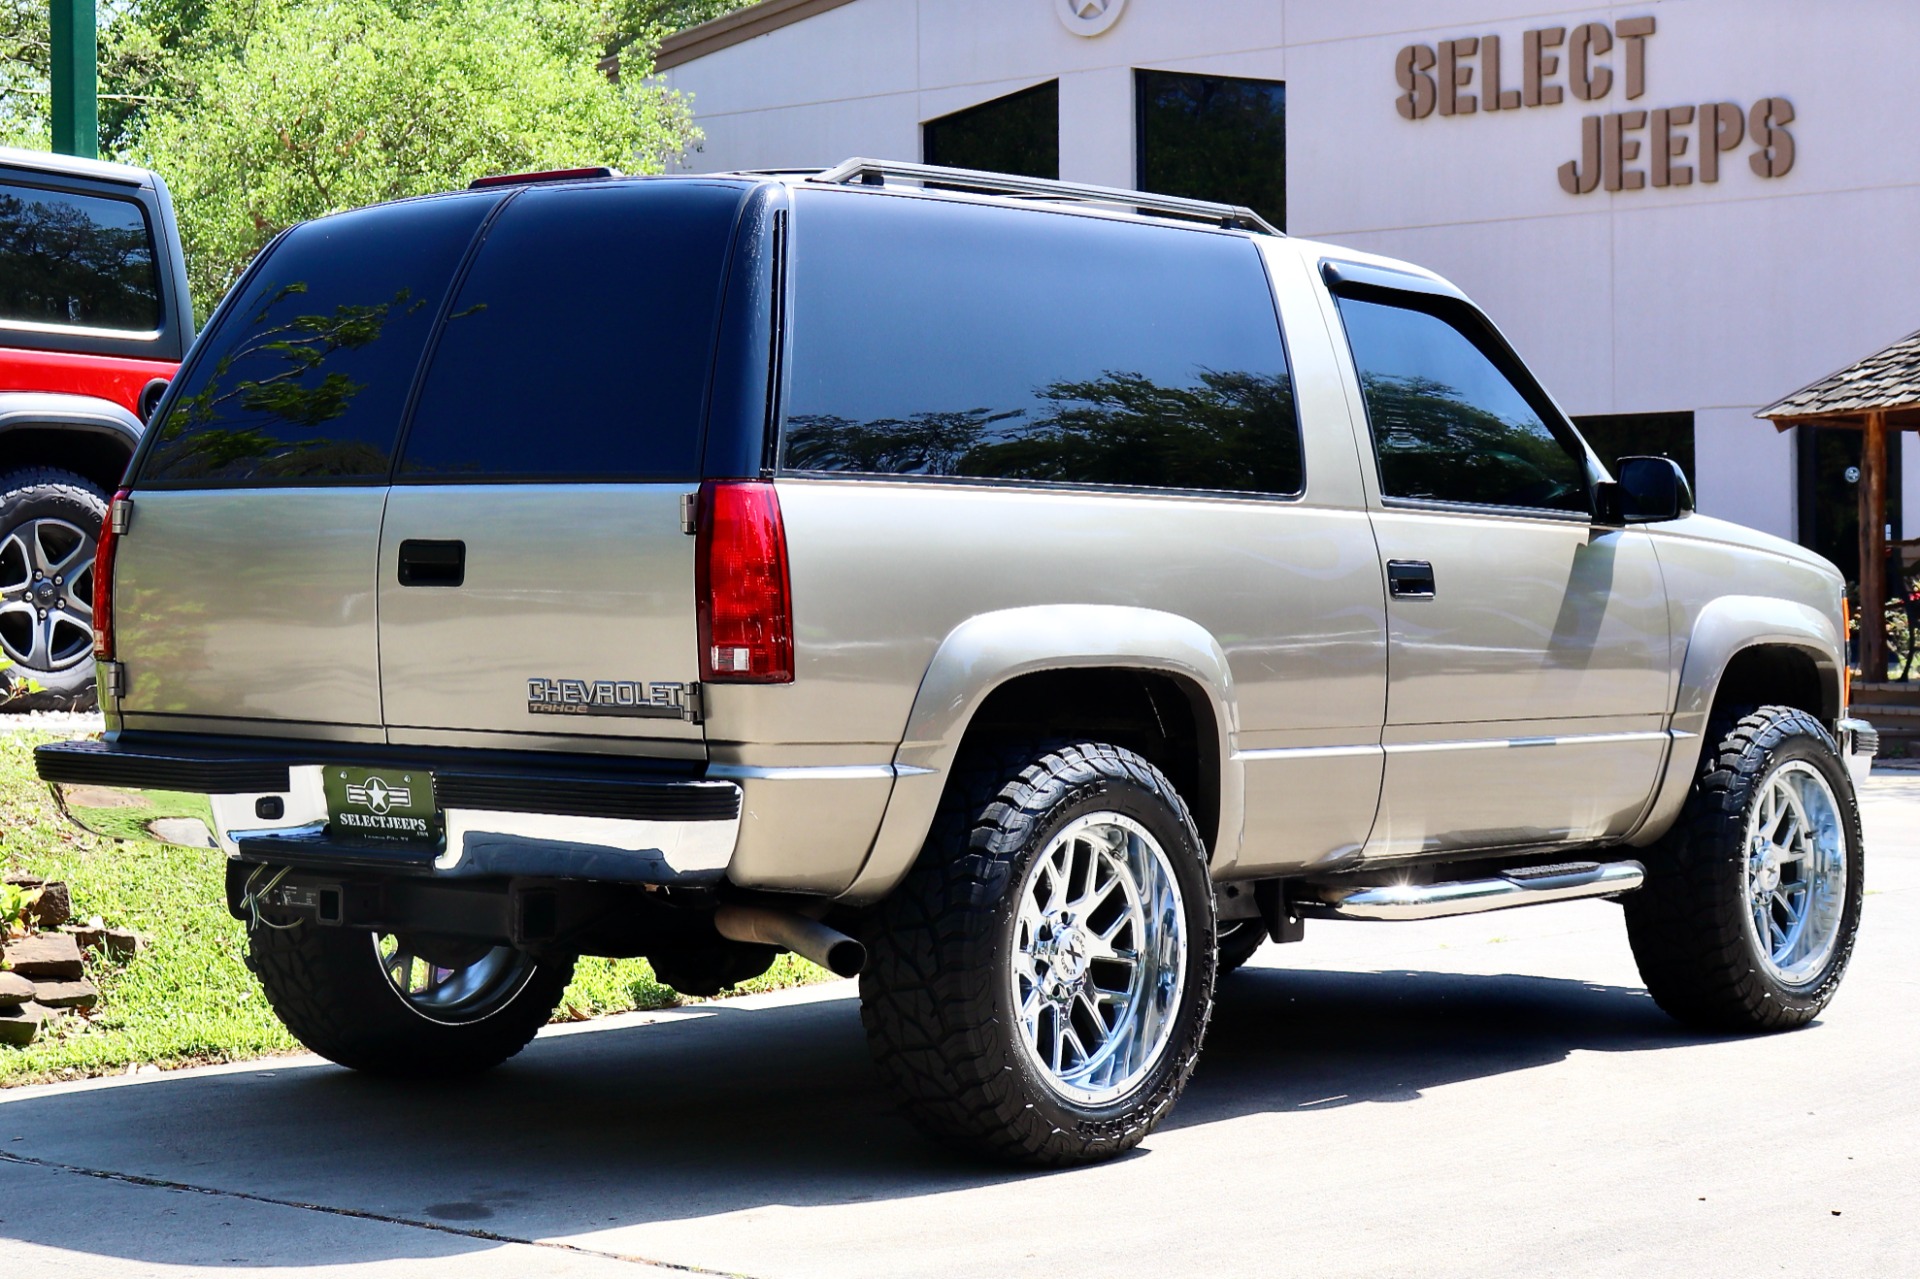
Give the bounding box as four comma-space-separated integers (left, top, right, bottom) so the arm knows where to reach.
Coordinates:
960, 666, 1219, 853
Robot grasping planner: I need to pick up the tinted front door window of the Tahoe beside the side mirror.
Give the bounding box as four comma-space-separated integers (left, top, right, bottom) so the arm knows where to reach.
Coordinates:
1340, 298, 1588, 511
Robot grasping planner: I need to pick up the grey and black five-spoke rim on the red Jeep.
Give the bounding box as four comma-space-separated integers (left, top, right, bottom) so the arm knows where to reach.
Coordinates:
0, 519, 96, 672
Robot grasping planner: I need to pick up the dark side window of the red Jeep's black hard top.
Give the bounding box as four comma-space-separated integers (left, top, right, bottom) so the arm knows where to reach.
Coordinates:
0, 184, 159, 332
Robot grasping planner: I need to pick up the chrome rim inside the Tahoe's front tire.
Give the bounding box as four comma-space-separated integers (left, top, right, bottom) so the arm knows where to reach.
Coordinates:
1745, 760, 1847, 987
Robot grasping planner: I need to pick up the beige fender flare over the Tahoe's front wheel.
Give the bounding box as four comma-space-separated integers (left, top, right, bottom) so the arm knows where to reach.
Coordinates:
1628, 595, 1847, 847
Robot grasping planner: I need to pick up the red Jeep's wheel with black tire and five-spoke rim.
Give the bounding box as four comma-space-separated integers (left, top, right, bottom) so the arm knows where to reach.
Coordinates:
0, 467, 108, 711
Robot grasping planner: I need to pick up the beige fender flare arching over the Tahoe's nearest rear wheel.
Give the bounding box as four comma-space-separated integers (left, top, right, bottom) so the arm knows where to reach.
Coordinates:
841, 605, 1244, 903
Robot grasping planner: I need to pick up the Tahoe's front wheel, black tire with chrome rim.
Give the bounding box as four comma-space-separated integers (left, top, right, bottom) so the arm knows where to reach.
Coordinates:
1622, 707, 1862, 1031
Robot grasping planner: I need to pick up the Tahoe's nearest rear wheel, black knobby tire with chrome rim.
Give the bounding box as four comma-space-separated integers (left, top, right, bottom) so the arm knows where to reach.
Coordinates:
860, 745, 1213, 1166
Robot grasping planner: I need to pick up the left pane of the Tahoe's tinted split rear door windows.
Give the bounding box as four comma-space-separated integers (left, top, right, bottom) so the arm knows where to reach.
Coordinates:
140, 192, 499, 484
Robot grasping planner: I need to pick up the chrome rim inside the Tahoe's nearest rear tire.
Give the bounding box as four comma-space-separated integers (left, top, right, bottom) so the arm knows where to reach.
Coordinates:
1012, 812, 1187, 1106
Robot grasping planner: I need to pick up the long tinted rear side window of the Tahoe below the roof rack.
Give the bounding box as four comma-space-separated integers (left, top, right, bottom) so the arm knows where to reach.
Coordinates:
783, 192, 1302, 494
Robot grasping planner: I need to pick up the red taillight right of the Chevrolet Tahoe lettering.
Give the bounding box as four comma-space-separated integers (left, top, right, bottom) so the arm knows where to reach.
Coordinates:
695, 480, 793, 684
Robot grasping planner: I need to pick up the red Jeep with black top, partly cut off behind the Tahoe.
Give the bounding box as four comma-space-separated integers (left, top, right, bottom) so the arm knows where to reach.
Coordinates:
0, 148, 194, 711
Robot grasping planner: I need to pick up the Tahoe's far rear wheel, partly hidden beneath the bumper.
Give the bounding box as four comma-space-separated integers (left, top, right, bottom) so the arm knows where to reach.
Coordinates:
248, 924, 574, 1077
